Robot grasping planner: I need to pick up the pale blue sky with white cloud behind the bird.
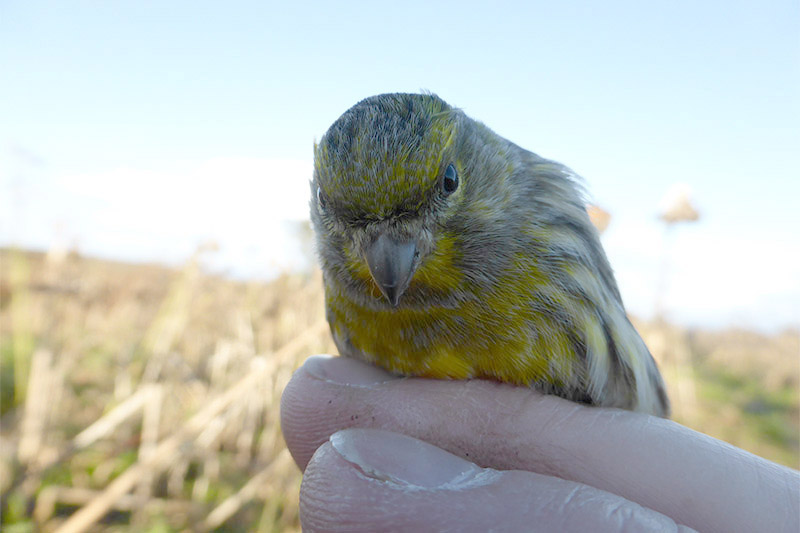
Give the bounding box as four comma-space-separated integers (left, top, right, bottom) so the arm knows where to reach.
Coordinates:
0, 0, 800, 329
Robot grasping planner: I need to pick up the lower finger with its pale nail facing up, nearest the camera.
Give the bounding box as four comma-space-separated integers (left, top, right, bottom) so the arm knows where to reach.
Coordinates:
300, 429, 689, 532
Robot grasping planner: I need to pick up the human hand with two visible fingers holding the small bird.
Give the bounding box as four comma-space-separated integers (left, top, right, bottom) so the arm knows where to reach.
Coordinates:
281, 357, 800, 532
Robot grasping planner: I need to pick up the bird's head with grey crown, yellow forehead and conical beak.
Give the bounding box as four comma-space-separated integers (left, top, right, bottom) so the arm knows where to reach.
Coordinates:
311, 94, 482, 307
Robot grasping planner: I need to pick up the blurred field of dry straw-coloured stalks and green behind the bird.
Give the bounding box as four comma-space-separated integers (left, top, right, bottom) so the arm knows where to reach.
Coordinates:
0, 250, 800, 533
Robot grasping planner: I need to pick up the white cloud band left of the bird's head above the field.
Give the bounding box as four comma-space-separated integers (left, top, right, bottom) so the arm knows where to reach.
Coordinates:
0, 158, 312, 277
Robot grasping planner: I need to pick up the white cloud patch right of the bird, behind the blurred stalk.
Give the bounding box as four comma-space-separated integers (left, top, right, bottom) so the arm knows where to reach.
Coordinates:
604, 221, 800, 330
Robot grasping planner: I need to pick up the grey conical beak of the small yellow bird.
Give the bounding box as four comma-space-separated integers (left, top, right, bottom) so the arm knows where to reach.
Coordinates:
364, 233, 417, 307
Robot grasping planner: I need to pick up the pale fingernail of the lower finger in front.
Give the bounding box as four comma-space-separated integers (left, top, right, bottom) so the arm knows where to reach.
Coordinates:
330, 428, 499, 490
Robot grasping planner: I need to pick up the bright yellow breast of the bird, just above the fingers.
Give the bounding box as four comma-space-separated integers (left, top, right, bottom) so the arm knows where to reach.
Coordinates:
326, 280, 575, 385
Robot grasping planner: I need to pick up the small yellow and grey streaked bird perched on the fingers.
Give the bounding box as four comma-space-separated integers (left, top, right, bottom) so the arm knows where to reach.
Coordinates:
310, 93, 669, 417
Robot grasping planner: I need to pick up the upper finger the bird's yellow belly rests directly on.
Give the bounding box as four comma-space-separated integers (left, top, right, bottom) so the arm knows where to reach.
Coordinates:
282, 358, 800, 531
